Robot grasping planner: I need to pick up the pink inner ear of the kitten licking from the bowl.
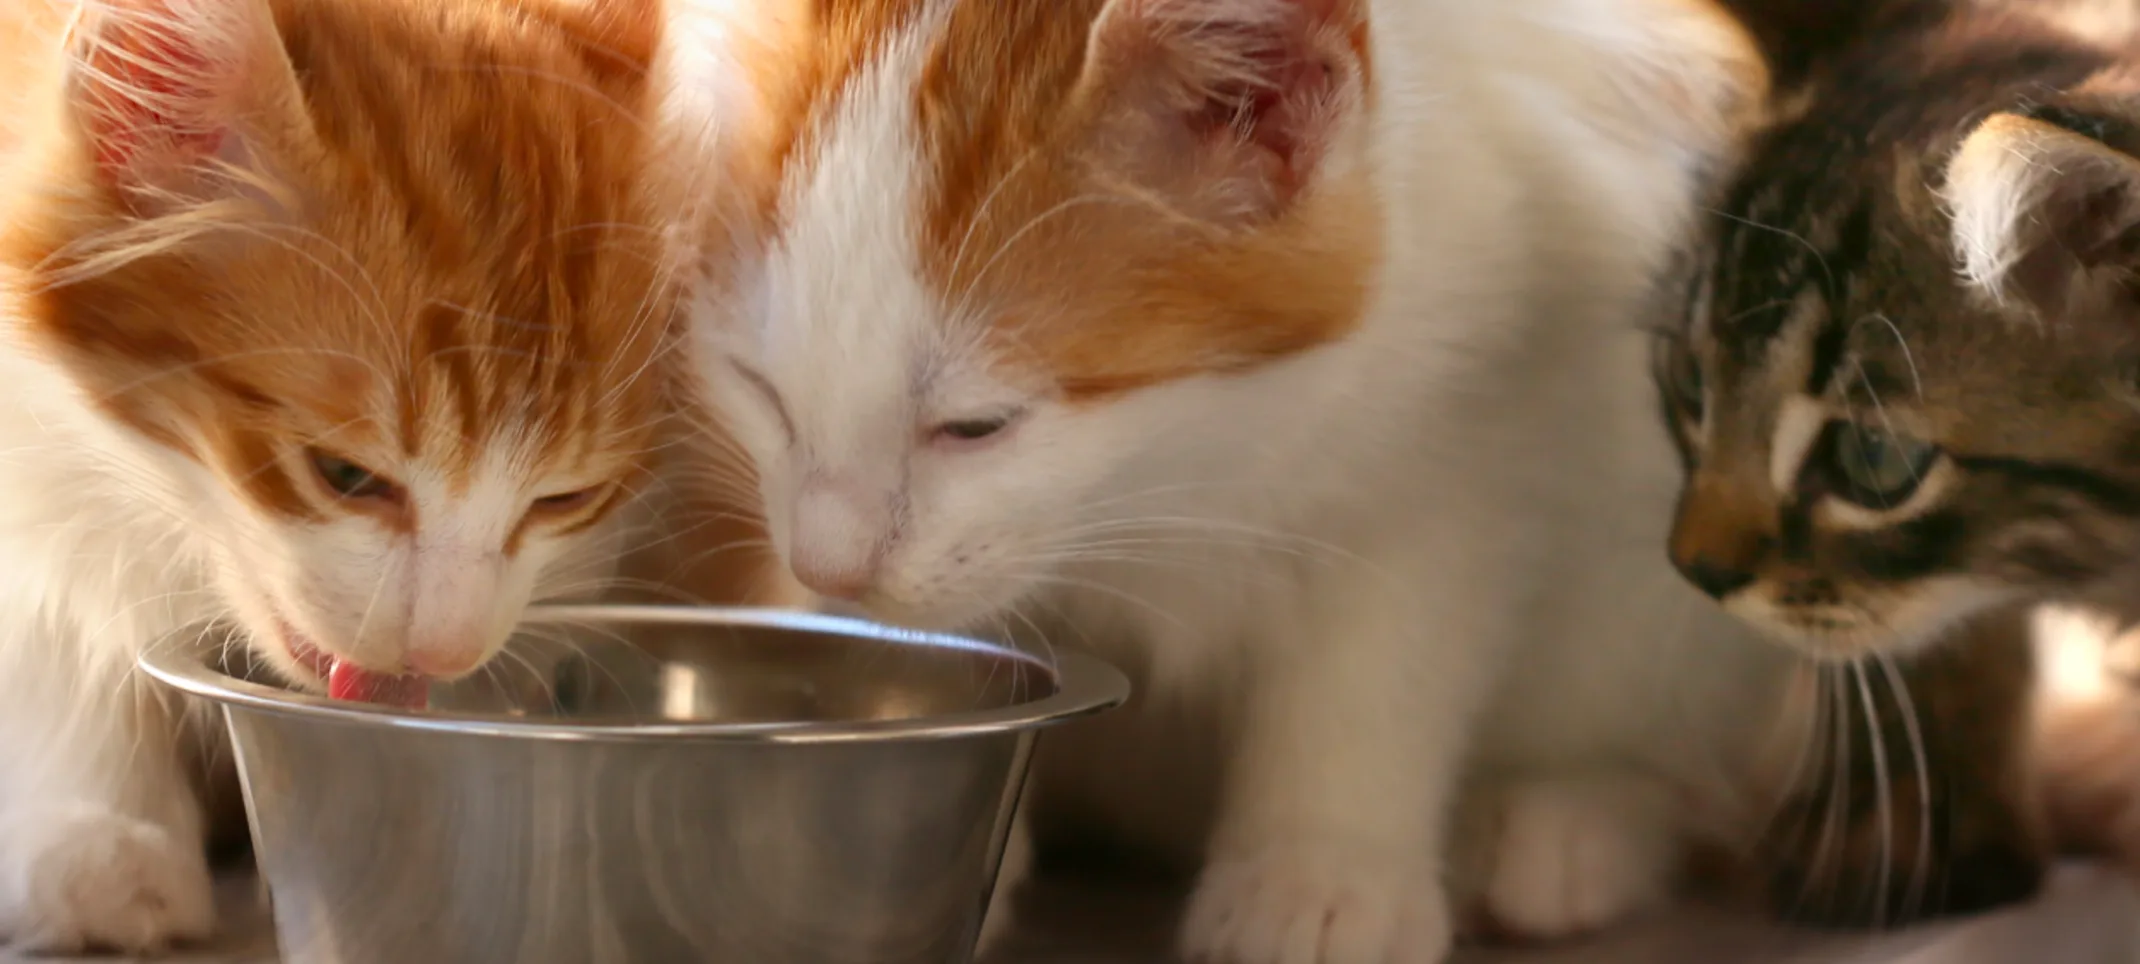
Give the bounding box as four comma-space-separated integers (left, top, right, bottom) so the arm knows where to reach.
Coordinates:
77, 13, 227, 184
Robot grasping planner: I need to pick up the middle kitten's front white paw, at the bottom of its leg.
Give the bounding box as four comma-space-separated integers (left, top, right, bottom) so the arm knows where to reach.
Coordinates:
1181, 846, 1451, 964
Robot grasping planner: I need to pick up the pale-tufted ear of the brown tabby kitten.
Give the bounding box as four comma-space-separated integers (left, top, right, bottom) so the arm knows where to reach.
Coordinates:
1941, 107, 2140, 317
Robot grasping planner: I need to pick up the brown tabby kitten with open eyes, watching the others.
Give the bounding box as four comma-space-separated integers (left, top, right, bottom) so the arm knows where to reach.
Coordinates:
1661, 0, 2140, 923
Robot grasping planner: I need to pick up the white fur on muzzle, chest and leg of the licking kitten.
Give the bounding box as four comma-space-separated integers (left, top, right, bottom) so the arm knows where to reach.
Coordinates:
0, 329, 624, 951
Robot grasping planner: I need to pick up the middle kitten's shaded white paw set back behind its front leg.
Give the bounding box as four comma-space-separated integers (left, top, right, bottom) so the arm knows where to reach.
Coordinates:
1485, 782, 1678, 940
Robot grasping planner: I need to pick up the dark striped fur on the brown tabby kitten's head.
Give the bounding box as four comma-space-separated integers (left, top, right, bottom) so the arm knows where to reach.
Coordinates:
1661, 4, 2140, 656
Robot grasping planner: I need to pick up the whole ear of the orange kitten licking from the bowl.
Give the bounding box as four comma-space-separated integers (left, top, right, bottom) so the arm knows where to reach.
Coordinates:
66, 0, 293, 204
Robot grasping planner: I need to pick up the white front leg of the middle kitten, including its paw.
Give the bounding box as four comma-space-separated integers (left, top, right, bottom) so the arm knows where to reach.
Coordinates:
1181, 548, 1509, 964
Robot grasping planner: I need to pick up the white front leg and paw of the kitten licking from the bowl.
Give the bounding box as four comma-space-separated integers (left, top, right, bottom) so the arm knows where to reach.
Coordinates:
0, 641, 214, 953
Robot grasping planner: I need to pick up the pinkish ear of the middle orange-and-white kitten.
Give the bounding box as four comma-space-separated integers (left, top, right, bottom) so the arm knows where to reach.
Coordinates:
1079, 0, 1370, 227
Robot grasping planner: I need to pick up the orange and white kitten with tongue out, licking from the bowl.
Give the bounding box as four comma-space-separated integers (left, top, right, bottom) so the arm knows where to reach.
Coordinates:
0, 0, 670, 951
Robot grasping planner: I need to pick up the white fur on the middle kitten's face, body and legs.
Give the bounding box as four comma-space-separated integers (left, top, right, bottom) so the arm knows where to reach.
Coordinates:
676, 0, 1783, 964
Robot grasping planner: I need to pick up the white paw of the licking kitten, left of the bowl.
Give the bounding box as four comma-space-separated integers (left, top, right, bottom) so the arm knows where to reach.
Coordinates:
0, 808, 216, 953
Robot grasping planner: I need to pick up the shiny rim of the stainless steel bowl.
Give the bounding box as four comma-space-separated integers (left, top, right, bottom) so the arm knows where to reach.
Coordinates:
139, 604, 1130, 743
